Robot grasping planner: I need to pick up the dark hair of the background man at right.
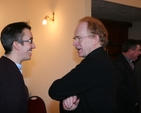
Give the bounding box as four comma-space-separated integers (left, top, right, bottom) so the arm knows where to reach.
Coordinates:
122, 39, 140, 52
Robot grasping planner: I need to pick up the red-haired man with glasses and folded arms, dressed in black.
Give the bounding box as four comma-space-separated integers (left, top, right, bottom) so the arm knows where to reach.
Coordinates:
49, 17, 117, 113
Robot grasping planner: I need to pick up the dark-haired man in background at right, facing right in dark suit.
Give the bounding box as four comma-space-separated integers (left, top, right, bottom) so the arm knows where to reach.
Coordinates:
113, 39, 141, 113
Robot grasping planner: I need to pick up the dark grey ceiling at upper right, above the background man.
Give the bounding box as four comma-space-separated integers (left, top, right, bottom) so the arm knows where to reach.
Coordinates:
92, 0, 141, 23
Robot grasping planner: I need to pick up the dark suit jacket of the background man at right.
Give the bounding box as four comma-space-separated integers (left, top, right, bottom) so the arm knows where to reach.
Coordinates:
114, 54, 138, 113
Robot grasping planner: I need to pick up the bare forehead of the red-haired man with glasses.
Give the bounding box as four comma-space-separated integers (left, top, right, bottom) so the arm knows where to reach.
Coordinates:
74, 22, 88, 36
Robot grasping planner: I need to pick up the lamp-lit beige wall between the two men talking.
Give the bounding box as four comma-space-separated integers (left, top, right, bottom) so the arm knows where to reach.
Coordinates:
24, 0, 91, 113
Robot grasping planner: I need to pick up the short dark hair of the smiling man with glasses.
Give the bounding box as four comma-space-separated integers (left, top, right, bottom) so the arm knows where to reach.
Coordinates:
0, 22, 31, 54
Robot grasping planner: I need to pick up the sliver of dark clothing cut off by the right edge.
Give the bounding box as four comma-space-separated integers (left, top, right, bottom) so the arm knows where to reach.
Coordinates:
135, 59, 141, 113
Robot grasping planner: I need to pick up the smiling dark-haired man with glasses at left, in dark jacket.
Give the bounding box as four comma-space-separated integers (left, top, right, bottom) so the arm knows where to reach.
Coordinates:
0, 22, 35, 113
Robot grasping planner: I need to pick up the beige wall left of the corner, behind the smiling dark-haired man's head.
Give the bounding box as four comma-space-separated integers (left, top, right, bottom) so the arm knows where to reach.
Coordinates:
0, 0, 28, 55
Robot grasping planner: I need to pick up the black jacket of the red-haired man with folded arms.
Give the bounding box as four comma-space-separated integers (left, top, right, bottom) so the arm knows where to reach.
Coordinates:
49, 47, 117, 113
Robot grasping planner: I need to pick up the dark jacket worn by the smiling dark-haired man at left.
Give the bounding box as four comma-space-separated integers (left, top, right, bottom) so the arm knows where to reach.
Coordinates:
0, 56, 27, 113
